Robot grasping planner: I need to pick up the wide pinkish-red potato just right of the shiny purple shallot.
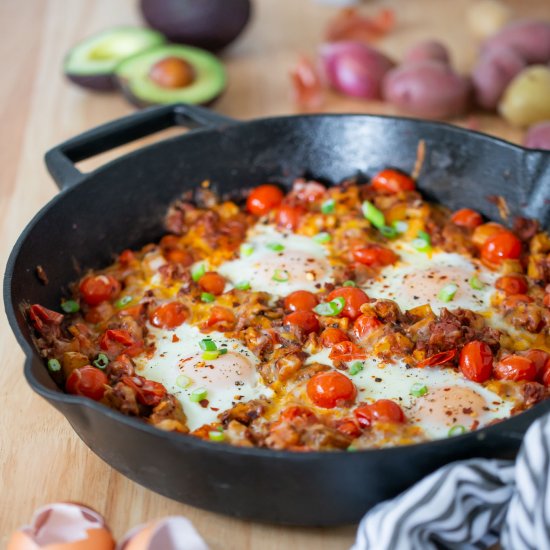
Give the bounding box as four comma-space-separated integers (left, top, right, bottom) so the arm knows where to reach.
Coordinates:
382, 61, 471, 118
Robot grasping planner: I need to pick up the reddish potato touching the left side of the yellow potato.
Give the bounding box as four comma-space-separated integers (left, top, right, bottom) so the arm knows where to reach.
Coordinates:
472, 45, 527, 110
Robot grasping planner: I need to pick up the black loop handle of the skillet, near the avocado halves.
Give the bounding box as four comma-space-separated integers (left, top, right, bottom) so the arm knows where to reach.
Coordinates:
45, 103, 235, 189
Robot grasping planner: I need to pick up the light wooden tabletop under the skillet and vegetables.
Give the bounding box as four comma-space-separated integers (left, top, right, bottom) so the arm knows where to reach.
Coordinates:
0, 0, 550, 550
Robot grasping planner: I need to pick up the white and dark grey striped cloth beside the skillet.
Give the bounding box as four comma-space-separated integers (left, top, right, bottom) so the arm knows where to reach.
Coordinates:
352, 414, 550, 550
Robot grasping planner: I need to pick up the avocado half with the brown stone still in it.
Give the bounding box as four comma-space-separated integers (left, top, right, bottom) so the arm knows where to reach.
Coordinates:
116, 45, 227, 107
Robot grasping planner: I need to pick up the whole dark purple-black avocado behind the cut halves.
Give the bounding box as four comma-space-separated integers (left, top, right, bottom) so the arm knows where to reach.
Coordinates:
140, 0, 252, 52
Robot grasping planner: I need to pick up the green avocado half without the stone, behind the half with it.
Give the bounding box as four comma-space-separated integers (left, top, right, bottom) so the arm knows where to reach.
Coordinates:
63, 27, 166, 91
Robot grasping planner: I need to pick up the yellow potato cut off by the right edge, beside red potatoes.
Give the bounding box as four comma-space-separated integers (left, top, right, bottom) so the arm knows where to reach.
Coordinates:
498, 65, 550, 126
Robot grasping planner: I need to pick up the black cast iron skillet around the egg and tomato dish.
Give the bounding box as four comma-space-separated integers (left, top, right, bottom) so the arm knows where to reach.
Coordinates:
4, 105, 550, 525
